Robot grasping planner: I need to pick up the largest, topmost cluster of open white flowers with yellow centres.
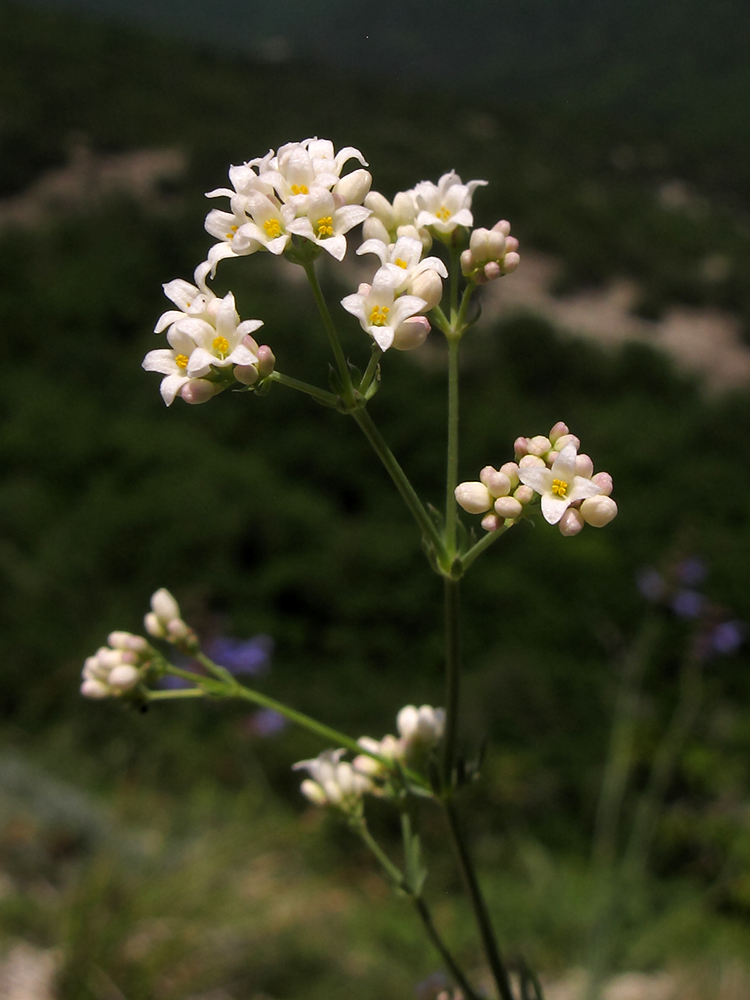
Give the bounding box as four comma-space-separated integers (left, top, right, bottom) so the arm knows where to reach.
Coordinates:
206, 138, 372, 273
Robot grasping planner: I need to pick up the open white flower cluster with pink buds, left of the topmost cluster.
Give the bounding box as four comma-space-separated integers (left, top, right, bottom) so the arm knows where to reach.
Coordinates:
143, 261, 276, 406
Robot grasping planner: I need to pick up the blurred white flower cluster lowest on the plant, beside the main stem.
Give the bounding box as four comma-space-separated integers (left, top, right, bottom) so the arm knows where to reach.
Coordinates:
294, 705, 445, 814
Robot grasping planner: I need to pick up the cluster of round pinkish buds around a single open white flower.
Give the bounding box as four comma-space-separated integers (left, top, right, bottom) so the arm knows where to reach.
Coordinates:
456, 422, 617, 536
